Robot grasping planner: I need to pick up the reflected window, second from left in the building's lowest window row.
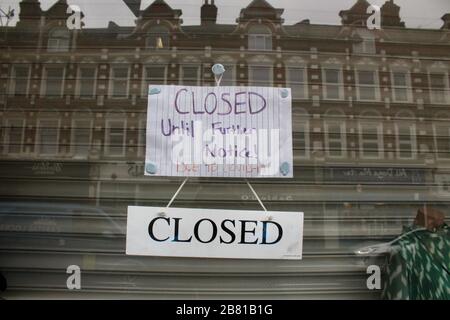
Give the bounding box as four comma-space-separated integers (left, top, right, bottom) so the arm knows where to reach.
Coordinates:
37, 119, 59, 156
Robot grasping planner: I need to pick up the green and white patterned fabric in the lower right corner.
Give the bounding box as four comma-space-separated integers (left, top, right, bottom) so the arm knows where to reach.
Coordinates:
382, 224, 450, 300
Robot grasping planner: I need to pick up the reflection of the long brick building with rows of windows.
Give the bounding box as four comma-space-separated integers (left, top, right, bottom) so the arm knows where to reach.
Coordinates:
0, 0, 450, 298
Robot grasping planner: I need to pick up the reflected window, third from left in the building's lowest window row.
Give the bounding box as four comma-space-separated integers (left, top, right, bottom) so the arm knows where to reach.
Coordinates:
72, 119, 92, 159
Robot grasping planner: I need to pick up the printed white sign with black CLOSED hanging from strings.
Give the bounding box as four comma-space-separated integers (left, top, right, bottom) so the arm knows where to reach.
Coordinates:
126, 206, 303, 260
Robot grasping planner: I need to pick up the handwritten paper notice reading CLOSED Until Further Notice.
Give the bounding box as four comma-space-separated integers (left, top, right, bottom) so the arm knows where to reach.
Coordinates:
145, 85, 293, 178
